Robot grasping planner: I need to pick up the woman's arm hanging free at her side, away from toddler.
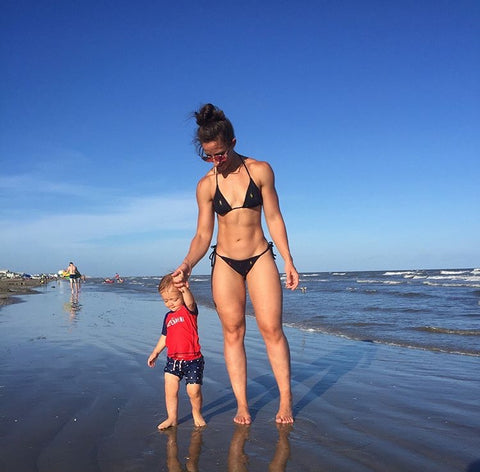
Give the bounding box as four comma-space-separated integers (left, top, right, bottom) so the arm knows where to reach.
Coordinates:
256, 161, 298, 290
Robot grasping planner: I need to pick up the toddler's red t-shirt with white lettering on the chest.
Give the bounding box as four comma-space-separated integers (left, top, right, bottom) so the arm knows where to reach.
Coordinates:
162, 305, 202, 361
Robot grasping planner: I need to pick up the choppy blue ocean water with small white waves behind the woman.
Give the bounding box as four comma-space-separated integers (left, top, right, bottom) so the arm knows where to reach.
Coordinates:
84, 268, 480, 356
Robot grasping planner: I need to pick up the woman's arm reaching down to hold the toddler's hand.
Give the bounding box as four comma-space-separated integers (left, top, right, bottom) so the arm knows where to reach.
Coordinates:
172, 175, 215, 288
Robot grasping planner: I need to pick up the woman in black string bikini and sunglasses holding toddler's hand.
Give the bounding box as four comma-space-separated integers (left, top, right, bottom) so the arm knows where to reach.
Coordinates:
173, 104, 298, 424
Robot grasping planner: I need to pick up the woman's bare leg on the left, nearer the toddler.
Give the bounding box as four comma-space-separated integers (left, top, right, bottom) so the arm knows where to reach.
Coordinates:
212, 257, 252, 424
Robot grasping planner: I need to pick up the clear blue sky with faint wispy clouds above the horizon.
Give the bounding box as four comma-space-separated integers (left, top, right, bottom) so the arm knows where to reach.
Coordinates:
0, 0, 480, 276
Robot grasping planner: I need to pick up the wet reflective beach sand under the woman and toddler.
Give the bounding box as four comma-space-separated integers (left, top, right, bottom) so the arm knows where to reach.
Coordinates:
0, 281, 480, 472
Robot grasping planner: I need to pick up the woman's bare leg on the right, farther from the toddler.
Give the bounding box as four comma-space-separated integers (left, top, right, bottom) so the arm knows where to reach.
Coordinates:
247, 253, 293, 423
